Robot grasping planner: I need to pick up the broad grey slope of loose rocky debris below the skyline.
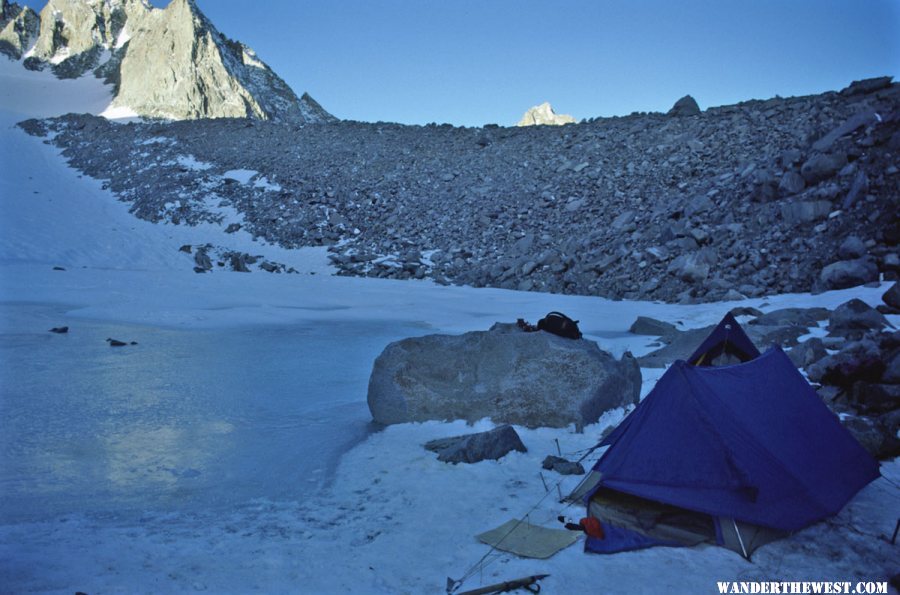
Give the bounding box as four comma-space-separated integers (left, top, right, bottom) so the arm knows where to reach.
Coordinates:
15, 79, 900, 302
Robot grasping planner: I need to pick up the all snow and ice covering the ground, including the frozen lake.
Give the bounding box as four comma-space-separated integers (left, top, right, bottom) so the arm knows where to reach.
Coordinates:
0, 59, 900, 595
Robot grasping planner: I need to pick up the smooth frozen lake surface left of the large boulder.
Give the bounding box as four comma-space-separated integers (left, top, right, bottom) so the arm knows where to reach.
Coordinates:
0, 304, 427, 523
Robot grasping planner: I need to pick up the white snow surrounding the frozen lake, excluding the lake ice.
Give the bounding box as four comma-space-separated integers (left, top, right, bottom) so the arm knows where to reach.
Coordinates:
0, 59, 900, 595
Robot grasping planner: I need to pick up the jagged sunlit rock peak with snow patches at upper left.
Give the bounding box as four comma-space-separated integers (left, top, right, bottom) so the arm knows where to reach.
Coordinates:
0, 0, 335, 122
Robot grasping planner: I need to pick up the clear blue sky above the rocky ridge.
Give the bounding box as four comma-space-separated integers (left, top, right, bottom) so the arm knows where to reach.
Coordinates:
15, 0, 900, 125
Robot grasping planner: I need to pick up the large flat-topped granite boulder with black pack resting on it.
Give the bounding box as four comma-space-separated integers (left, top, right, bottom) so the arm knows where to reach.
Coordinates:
368, 324, 641, 429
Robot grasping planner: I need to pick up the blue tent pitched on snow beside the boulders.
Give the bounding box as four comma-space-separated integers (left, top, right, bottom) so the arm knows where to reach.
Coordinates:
586, 317, 879, 558
